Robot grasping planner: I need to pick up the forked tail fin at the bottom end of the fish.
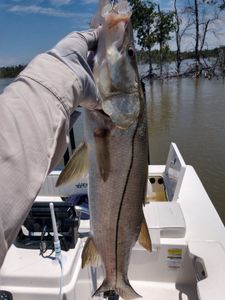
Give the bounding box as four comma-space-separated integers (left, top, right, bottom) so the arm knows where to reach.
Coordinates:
93, 280, 141, 300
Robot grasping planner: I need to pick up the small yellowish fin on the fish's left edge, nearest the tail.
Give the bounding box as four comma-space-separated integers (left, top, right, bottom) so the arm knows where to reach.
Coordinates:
82, 237, 99, 268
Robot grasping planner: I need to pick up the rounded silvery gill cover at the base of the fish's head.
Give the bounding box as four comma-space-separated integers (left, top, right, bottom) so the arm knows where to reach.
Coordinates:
102, 92, 140, 130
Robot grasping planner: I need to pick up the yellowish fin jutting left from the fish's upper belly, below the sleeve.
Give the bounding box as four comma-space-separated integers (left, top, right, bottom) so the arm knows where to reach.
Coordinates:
56, 143, 88, 187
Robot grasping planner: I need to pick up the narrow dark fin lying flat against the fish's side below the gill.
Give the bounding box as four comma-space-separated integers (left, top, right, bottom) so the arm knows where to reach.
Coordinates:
94, 128, 110, 182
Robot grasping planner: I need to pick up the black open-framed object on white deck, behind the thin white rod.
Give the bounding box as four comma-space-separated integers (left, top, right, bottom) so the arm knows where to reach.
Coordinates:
15, 201, 79, 254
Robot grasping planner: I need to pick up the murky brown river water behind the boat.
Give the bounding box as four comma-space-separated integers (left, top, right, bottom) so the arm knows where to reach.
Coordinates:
0, 78, 225, 224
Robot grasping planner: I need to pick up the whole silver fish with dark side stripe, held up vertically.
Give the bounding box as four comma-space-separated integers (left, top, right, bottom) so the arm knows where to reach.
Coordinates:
57, 1, 151, 299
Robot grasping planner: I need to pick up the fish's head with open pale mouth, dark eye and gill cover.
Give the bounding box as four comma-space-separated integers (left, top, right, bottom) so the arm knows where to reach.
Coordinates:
93, 1, 140, 129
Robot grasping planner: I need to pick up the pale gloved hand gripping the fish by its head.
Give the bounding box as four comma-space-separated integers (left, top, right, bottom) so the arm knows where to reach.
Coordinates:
48, 27, 101, 109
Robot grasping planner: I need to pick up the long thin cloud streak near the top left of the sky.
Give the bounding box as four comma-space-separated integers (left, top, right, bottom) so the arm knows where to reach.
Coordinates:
8, 5, 77, 18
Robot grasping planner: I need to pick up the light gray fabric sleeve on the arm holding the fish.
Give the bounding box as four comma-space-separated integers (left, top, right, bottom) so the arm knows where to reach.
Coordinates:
0, 54, 85, 266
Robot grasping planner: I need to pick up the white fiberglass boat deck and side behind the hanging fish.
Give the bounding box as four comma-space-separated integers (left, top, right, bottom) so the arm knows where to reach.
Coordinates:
0, 144, 225, 300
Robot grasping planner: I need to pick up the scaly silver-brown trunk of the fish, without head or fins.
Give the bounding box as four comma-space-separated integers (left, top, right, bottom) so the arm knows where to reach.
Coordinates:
86, 105, 147, 289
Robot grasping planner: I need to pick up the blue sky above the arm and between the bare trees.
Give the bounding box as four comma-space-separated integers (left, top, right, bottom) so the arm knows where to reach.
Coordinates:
0, 0, 225, 67
